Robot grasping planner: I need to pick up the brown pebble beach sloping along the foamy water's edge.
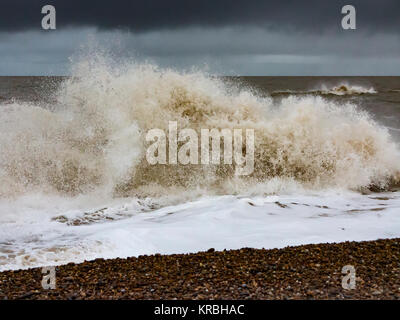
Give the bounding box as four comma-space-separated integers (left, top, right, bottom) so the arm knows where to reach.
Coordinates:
0, 239, 400, 300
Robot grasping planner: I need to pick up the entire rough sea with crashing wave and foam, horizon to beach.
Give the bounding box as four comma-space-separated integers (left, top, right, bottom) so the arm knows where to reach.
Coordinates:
0, 59, 400, 271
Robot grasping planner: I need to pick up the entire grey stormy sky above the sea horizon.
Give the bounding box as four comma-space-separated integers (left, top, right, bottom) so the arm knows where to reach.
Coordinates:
0, 0, 400, 75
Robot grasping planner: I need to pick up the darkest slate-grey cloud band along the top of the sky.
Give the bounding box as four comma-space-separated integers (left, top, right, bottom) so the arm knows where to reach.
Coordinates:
0, 0, 400, 33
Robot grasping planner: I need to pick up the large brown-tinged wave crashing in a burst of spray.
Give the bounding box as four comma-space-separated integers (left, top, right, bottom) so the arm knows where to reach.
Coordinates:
0, 57, 400, 197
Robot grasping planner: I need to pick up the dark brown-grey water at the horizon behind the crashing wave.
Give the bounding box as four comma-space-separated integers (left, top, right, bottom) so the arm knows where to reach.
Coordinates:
0, 76, 400, 141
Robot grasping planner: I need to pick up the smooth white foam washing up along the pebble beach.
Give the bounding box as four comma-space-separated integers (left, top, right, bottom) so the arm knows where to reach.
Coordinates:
0, 192, 400, 270
